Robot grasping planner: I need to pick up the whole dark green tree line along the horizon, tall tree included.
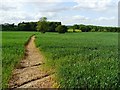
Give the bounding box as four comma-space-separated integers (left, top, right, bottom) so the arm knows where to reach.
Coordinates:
0, 17, 120, 33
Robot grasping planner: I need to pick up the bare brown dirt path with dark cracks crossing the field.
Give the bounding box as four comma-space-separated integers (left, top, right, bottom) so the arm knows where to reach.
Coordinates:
9, 36, 55, 88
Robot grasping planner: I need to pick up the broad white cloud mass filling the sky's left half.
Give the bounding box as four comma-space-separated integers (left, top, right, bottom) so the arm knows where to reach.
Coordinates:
0, 0, 60, 23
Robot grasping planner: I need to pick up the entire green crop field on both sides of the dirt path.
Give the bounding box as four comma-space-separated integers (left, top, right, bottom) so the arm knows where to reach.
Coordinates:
2, 32, 119, 88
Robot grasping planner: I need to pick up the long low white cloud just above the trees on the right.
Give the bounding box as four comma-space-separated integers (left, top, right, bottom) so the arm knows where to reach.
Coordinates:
61, 15, 117, 26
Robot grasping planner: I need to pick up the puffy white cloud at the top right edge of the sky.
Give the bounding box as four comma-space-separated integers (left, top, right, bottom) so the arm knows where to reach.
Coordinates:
73, 0, 114, 11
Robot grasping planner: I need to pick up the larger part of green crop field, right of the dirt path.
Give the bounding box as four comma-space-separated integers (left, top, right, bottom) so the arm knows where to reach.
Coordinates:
36, 32, 119, 88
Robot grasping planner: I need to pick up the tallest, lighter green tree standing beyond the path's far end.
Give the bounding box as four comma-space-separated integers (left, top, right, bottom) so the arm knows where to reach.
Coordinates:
36, 17, 48, 33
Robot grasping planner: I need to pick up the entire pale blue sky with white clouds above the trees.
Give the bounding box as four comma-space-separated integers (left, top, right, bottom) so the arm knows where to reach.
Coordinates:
0, 0, 119, 26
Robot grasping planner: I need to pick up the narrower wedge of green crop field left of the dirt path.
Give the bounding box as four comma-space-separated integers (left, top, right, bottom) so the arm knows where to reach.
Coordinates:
2, 32, 33, 88
